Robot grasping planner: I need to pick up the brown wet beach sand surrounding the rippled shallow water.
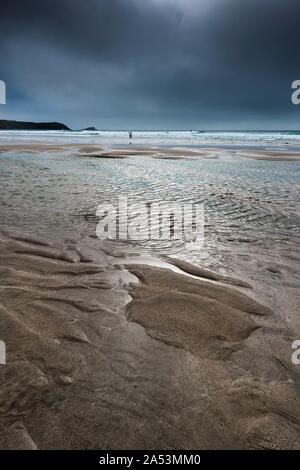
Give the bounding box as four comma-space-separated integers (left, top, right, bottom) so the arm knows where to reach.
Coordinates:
0, 141, 300, 449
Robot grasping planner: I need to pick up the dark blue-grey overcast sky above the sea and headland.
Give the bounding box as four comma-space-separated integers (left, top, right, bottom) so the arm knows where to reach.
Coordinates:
0, 0, 300, 129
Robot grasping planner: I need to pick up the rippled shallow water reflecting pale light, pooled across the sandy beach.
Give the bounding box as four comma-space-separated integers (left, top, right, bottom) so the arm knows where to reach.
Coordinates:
0, 134, 300, 266
